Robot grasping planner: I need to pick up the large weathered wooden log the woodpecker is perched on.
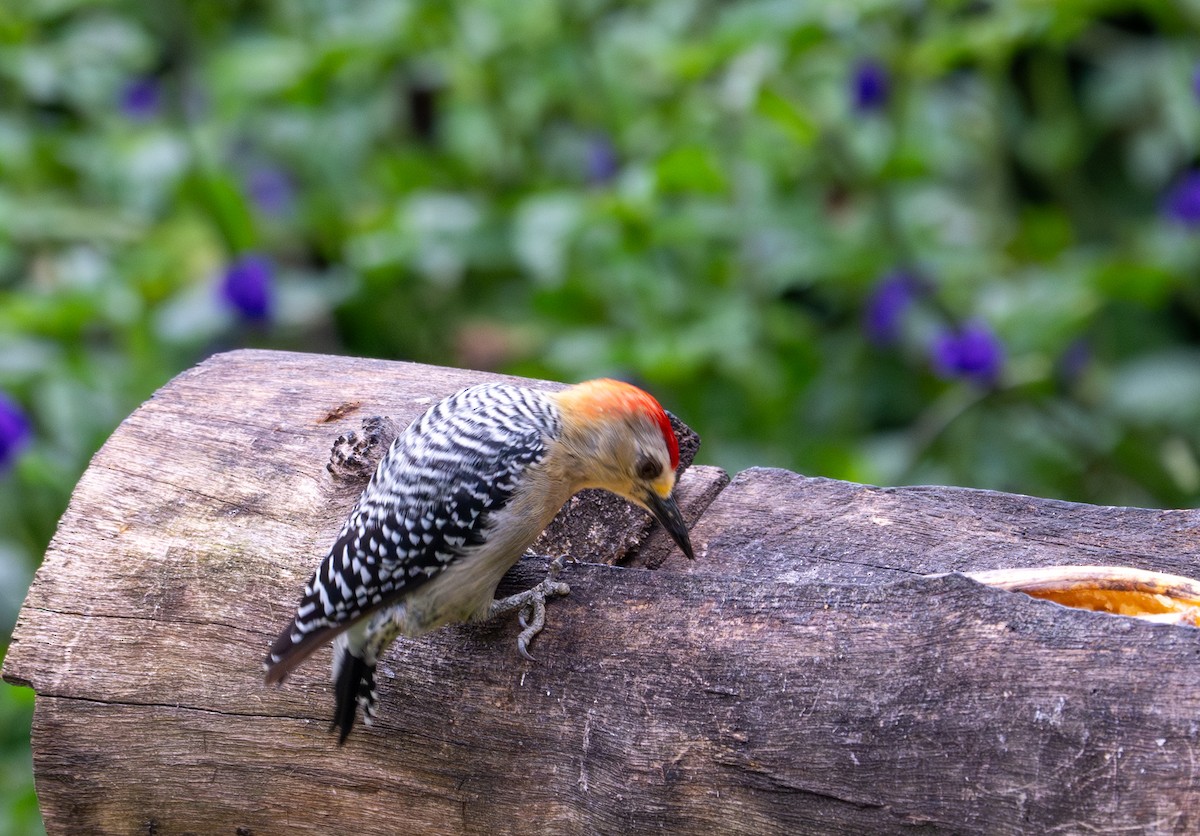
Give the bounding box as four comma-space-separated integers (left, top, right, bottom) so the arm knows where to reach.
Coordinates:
4, 351, 1200, 835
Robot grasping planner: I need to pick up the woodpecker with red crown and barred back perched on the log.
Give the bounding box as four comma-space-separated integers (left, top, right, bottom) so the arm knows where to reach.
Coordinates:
265, 380, 695, 744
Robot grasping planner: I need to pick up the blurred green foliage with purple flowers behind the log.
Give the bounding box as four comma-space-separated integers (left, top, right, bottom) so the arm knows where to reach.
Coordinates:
0, 0, 1200, 832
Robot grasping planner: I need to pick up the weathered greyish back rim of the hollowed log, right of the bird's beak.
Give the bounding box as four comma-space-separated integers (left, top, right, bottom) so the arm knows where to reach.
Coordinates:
691, 468, 1200, 583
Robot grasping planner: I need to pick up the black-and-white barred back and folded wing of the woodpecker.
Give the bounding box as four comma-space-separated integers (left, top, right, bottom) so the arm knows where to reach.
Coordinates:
266, 384, 558, 681
